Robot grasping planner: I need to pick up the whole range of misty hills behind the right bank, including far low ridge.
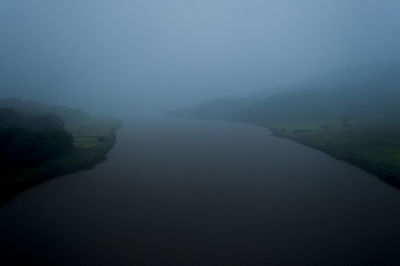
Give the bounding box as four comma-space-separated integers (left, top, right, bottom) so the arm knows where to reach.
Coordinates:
179, 62, 400, 121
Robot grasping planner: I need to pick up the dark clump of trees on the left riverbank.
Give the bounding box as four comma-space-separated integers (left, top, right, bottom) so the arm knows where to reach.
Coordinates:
0, 108, 73, 169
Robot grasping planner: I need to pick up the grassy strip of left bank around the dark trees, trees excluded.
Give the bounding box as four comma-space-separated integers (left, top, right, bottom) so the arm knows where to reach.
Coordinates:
0, 120, 121, 205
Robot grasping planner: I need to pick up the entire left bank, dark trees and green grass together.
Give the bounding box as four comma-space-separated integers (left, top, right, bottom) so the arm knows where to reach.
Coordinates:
0, 99, 120, 202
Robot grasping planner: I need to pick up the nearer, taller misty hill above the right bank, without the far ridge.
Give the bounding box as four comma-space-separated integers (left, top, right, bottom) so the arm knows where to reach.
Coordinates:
231, 61, 400, 121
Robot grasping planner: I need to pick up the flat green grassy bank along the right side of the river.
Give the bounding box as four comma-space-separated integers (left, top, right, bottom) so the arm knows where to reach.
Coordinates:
247, 121, 400, 188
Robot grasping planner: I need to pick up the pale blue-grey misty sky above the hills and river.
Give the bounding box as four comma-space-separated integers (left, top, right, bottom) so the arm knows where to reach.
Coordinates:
0, 0, 400, 113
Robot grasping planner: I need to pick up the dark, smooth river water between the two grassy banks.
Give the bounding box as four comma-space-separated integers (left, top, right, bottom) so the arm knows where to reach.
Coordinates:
0, 119, 400, 265
